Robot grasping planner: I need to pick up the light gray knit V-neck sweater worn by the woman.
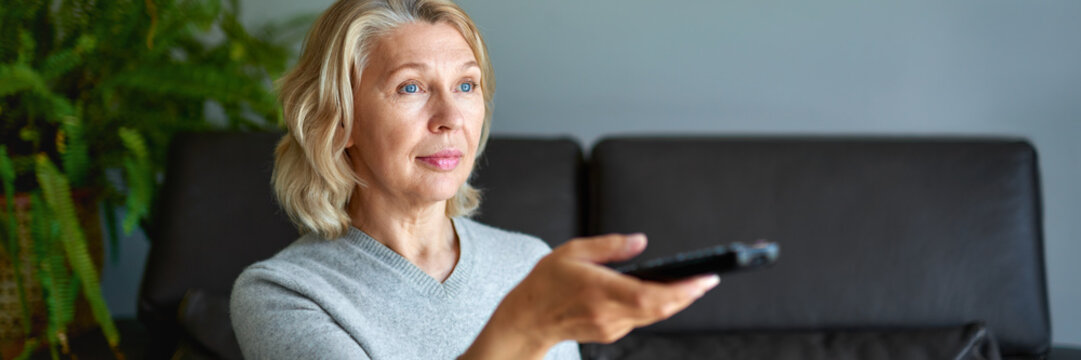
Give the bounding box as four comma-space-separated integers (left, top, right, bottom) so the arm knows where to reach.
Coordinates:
230, 218, 579, 359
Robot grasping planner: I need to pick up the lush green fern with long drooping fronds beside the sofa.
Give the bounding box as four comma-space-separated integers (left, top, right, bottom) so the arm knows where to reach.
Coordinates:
0, 0, 311, 358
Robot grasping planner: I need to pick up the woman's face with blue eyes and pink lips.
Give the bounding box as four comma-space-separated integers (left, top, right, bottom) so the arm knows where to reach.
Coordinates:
347, 23, 484, 204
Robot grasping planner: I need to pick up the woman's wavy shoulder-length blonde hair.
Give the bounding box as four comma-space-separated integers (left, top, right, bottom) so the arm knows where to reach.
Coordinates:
271, 0, 495, 239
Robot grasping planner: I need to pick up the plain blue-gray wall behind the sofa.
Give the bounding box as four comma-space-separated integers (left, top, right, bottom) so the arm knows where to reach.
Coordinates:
103, 0, 1081, 345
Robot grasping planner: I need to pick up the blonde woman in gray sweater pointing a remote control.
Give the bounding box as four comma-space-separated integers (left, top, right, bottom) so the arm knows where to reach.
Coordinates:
231, 0, 718, 359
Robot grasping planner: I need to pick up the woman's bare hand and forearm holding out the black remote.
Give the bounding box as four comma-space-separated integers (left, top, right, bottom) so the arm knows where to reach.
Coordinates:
463, 234, 720, 359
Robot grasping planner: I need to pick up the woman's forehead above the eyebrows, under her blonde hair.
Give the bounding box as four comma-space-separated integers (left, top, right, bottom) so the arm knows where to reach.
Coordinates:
366, 23, 476, 71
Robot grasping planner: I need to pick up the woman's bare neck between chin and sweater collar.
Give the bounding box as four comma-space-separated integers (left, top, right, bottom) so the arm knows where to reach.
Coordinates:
348, 184, 458, 280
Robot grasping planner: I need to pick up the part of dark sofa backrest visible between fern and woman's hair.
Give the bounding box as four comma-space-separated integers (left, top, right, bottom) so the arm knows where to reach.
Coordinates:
137, 133, 297, 359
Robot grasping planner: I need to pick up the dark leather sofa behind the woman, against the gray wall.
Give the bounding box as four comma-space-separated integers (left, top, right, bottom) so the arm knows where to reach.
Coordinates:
130, 133, 1081, 359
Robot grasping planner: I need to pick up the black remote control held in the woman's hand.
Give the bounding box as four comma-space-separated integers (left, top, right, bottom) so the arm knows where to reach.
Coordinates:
615, 240, 780, 282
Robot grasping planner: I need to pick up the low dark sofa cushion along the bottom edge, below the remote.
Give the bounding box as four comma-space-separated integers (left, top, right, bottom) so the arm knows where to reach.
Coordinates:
582, 323, 1000, 360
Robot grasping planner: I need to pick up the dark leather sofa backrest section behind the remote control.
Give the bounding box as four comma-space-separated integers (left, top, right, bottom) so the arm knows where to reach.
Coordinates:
589, 137, 1050, 356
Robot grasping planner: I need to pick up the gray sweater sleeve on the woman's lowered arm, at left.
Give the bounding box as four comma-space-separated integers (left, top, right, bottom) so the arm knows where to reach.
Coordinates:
229, 266, 370, 359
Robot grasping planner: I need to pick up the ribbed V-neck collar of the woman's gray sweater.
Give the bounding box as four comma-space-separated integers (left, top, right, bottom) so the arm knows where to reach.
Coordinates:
345, 217, 475, 297
